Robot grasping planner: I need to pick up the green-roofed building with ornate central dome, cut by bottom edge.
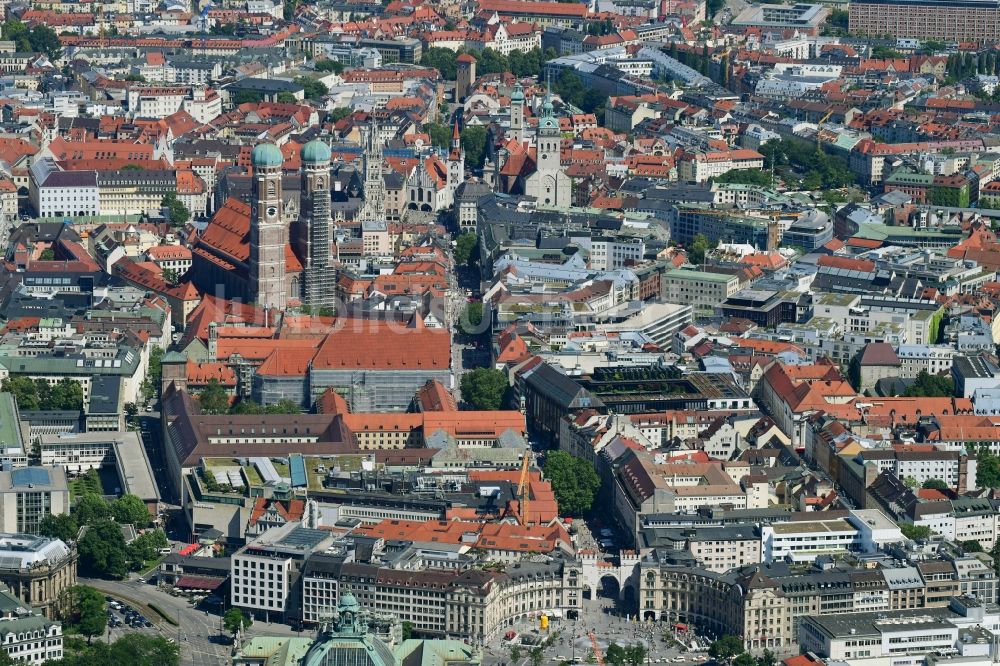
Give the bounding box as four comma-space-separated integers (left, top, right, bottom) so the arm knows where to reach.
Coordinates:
233, 592, 482, 666
